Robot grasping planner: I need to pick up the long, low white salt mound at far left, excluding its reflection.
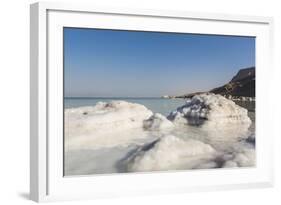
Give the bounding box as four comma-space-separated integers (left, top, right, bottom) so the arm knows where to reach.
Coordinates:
65, 101, 152, 135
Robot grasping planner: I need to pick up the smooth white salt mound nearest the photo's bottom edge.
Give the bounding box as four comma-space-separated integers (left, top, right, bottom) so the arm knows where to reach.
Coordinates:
127, 135, 216, 172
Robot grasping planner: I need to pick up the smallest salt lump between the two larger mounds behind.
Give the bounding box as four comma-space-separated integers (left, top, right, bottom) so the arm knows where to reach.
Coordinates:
143, 113, 174, 131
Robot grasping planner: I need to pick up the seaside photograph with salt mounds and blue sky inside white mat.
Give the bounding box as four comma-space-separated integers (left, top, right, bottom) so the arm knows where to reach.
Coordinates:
62, 27, 256, 176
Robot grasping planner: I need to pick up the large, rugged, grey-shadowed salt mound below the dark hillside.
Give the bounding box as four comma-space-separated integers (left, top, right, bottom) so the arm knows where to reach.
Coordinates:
168, 93, 251, 128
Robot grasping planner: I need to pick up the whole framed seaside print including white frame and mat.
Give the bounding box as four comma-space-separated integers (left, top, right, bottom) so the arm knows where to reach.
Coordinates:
30, 3, 273, 201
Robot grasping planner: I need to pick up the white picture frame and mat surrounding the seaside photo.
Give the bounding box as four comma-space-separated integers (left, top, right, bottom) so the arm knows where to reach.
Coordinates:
30, 2, 273, 202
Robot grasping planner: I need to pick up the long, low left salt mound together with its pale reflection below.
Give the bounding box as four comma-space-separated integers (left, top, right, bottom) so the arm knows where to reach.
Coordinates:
65, 101, 153, 149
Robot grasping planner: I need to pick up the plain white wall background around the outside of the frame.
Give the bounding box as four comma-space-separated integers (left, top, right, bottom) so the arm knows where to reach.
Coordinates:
0, 0, 281, 205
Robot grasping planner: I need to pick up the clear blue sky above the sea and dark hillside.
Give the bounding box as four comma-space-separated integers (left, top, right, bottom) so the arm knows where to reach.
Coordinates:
64, 28, 255, 97
